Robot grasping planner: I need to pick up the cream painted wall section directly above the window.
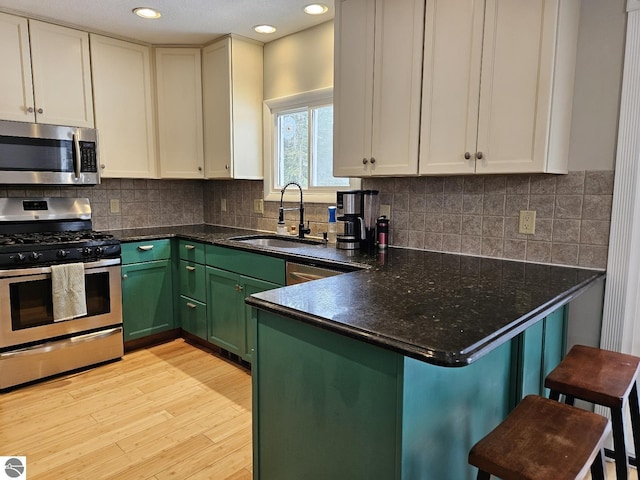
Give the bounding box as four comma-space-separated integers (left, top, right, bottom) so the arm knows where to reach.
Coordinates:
264, 20, 333, 100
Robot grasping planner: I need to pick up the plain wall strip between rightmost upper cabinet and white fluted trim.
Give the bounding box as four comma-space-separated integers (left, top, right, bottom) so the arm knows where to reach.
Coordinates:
569, 0, 627, 171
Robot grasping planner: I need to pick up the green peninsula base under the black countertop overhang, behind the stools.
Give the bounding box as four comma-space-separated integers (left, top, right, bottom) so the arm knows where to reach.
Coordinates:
252, 308, 566, 480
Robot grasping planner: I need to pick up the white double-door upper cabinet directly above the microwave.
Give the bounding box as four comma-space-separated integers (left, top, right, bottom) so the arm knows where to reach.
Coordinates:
0, 13, 94, 127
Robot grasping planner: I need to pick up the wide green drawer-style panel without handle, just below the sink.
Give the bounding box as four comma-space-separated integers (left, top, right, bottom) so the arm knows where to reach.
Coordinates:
206, 245, 285, 285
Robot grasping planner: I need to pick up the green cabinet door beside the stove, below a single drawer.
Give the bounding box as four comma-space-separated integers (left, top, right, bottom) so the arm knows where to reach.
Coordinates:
122, 260, 174, 341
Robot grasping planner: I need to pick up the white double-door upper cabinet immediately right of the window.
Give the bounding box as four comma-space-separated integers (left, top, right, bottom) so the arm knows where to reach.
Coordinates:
333, 0, 425, 177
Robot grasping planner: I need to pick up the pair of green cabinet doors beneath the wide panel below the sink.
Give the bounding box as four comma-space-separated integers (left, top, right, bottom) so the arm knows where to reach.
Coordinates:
206, 267, 279, 361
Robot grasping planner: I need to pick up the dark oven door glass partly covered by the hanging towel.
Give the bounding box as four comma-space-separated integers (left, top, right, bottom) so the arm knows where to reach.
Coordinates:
9, 272, 111, 330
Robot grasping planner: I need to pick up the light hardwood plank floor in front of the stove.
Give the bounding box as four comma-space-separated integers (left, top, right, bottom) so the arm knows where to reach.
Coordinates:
0, 340, 252, 480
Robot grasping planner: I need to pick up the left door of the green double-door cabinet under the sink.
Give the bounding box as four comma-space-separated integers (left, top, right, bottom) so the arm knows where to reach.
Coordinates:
206, 267, 245, 355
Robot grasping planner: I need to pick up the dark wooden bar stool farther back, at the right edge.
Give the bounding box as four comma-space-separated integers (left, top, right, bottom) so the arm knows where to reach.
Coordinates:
544, 345, 640, 480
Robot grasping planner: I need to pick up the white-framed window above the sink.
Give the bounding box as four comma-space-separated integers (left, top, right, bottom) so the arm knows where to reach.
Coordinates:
265, 89, 359, 203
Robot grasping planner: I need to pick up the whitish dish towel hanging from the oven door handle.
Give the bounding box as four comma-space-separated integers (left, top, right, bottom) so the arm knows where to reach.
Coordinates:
51, 263, 87, 322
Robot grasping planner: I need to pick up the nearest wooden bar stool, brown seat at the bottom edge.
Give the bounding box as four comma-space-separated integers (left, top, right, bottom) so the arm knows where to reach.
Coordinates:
469, 395, 611, 480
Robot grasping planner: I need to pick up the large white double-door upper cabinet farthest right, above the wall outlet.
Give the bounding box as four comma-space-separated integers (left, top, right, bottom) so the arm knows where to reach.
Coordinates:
420, 0, 580, 174
